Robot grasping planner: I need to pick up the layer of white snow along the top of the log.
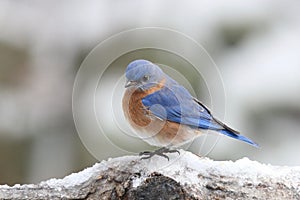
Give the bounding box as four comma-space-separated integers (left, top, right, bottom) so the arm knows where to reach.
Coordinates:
0, 150, 300, 190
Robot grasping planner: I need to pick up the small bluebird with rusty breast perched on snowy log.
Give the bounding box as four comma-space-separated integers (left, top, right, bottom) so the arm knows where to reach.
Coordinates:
122, 59, 258, 159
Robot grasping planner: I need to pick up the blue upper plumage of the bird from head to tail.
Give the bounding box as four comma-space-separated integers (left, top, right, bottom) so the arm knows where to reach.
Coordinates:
126, 60, 258, 147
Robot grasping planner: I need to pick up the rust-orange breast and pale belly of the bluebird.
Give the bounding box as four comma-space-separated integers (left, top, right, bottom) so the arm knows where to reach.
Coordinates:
122, 78, 199, 146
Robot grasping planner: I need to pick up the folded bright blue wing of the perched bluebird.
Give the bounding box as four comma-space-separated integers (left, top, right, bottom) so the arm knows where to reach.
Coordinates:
142, 85, 223, 130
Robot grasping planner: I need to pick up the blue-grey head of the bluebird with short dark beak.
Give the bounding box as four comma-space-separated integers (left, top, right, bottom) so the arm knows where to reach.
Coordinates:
125, 60, 164, 90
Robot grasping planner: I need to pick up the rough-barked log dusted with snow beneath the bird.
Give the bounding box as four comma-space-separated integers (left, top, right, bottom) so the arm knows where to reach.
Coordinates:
0, 150, 300, 199
